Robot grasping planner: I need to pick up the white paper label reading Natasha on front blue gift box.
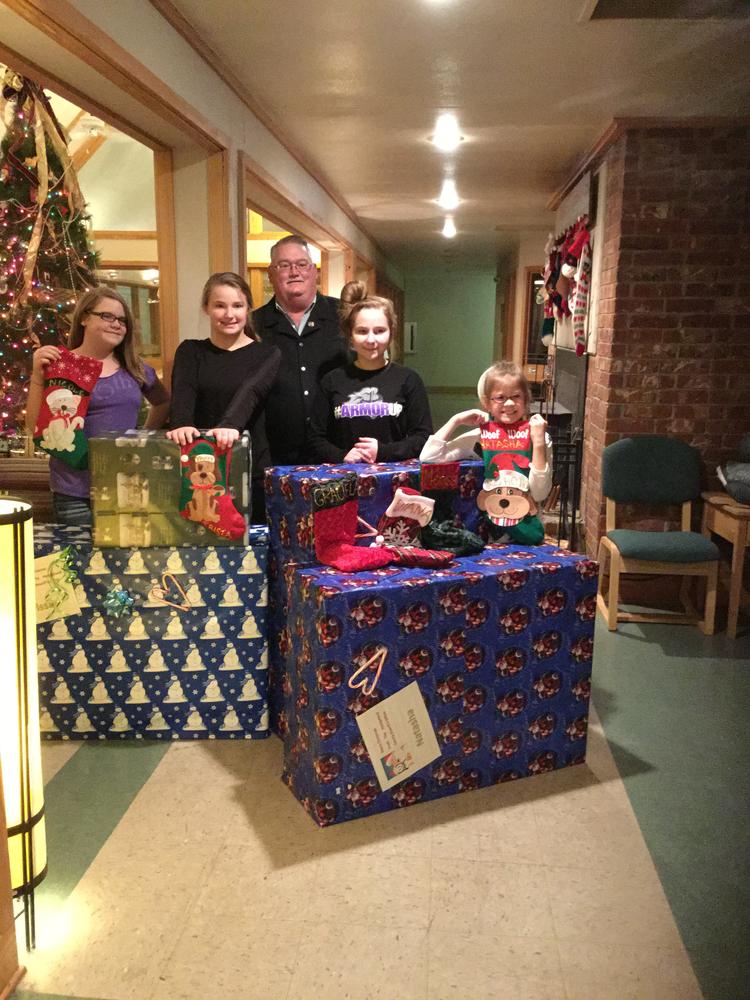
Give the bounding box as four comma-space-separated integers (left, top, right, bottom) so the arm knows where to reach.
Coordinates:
357, 682, 440, 791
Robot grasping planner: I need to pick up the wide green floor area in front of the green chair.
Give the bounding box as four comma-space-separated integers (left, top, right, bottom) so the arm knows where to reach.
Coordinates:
593, 623, 750, 1000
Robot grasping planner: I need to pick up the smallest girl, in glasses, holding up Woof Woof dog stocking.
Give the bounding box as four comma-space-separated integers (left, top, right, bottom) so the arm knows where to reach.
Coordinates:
419, 361, 552, 545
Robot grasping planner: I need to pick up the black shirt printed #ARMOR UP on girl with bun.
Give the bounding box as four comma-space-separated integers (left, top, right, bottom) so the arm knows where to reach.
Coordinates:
310, 362, 432, 462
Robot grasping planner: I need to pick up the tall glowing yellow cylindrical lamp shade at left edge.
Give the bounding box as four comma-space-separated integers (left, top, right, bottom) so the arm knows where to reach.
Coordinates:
0, 497, 47, 897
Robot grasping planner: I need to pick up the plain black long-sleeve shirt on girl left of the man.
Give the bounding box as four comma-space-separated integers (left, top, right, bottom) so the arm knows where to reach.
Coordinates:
169, 340, 281, 479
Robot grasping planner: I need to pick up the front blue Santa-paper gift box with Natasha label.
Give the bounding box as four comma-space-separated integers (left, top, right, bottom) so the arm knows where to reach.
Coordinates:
278, 545, 597, 826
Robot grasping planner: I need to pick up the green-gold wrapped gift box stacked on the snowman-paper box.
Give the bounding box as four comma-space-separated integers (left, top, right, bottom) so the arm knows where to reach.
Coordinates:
89, 430, 251, 548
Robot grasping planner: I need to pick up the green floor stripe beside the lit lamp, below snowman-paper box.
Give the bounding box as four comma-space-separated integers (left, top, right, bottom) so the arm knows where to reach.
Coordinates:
37, 742, 169, 906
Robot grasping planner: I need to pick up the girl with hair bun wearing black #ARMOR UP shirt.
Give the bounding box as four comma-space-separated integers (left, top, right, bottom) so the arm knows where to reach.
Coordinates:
310, 281, 432, 463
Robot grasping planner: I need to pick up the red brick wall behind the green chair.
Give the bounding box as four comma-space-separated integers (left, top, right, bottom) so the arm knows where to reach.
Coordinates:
581, 126, 750, 553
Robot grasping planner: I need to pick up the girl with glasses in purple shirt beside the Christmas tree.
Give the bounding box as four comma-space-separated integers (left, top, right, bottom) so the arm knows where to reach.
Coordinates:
26, 287, 169, 527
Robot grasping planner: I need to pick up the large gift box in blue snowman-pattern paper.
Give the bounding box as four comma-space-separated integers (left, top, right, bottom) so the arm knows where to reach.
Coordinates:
35, 525, 268, 740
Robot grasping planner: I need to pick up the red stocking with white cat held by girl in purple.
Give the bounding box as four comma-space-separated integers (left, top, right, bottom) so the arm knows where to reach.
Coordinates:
34, 347, 102, 469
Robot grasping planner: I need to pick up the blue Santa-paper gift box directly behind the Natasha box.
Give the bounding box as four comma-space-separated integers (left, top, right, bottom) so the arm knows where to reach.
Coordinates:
265, 459, 484, 732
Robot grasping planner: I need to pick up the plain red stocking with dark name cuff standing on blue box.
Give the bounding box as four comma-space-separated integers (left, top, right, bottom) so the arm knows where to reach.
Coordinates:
313, 472, 393, 573
